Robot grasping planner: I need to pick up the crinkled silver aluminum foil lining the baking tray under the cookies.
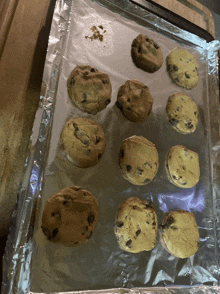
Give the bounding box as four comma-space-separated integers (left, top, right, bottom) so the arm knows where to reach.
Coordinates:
3, 0, 220, 293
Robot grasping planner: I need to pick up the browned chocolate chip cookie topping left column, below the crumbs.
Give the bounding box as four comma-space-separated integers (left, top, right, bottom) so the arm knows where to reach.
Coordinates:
67, 65, 112, 114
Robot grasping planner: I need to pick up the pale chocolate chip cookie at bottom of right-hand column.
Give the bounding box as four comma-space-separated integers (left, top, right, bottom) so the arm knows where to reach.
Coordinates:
160, 209, 200, 258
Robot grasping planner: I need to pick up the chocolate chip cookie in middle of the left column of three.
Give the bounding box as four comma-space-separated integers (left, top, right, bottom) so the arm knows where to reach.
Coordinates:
61, 117, 106, 168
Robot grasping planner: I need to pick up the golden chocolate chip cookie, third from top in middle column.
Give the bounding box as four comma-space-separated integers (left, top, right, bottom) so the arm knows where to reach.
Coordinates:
119, 136, 159, 185
